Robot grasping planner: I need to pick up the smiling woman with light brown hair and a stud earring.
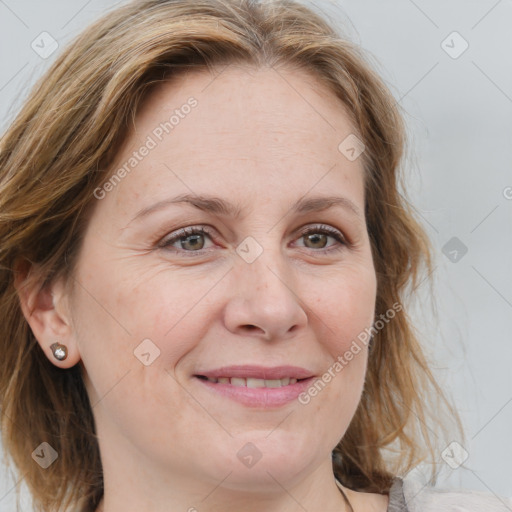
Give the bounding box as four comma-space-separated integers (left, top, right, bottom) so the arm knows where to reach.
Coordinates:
0, 0, 505, 512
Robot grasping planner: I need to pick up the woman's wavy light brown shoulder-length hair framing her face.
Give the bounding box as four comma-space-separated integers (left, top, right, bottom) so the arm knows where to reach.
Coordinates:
0, 0, 462, 512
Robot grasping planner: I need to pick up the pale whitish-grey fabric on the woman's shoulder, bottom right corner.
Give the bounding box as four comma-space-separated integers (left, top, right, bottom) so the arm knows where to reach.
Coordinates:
402, 477, 512, 512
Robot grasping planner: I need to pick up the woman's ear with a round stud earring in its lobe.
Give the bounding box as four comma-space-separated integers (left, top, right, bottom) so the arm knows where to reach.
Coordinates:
14, 262, 80, 368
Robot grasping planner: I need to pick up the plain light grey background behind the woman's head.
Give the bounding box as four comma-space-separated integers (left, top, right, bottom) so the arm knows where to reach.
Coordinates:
0, 0, 512, 512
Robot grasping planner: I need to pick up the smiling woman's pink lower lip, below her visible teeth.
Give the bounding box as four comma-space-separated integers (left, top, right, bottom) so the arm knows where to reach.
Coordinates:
194, 377, 315, 409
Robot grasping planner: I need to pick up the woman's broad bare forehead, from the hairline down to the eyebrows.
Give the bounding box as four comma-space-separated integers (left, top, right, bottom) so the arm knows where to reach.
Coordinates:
106, 65, 363, 216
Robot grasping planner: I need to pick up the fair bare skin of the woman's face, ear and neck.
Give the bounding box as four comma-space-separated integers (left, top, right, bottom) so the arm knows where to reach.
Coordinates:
22, 66, 388, 512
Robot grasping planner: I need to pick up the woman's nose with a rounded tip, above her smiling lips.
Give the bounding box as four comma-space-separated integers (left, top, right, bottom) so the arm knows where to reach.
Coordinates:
224, 250, 307, 341
